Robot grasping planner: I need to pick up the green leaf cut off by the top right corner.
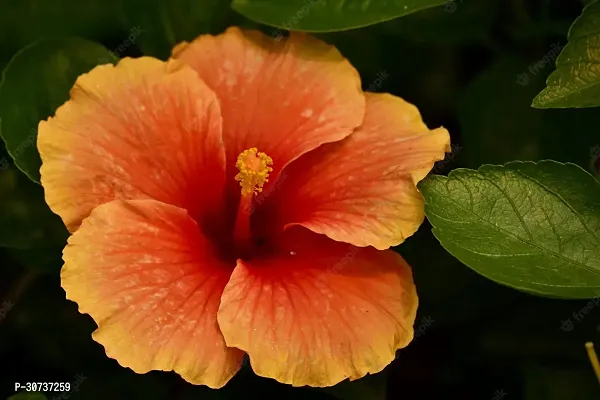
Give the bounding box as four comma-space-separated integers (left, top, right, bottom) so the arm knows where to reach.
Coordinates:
532, 1, 600, 108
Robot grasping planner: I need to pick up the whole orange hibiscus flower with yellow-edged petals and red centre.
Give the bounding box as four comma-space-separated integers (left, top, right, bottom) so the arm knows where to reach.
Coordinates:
38, 28, 449, 388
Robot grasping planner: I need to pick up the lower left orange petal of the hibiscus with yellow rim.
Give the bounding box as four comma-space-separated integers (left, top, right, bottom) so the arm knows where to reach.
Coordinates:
61, 200, 243, 388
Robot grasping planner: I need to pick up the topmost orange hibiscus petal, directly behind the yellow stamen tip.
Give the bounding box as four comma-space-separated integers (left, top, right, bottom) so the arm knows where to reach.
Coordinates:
173, 28, 365, 197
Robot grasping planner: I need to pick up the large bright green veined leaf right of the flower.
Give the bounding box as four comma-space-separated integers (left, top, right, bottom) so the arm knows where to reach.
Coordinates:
419, 161, 600, 298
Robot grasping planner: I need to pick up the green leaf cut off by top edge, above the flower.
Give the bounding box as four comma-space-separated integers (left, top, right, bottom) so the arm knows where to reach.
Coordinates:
231, 0, 453, 32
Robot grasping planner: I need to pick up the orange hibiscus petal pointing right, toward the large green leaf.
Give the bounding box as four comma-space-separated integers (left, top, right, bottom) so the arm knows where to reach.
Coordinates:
255, 93, 450, 250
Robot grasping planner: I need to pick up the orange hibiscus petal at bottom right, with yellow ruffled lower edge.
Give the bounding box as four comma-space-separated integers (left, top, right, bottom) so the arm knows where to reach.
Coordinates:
218, 228, 417, 387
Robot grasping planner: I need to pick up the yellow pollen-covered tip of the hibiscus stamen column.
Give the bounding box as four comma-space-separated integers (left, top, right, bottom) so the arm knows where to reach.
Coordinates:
235, 147, 273, 196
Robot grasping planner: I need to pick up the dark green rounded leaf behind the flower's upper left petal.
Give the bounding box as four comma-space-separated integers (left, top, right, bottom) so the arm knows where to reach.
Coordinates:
0, 38, 116, 182
